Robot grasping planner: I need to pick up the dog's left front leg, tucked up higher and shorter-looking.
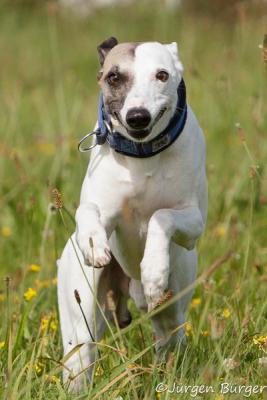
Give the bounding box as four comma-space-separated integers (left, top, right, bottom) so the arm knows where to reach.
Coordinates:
75, 203, 116, 267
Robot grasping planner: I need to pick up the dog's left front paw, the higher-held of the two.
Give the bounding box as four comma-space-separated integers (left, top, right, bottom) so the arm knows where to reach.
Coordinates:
77, 234, 111, 268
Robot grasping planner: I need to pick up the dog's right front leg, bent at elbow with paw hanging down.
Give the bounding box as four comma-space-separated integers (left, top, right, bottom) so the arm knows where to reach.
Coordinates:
141, 207, 204, 310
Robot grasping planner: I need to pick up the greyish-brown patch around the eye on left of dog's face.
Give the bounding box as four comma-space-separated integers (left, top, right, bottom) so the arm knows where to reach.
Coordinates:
98, 43, 139, 116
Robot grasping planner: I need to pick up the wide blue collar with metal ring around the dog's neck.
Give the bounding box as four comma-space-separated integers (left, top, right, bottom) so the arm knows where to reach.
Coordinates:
82, 79, 187, 158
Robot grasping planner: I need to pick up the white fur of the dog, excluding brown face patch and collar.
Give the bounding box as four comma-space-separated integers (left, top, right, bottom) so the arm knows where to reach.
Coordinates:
58, 43, 207, 389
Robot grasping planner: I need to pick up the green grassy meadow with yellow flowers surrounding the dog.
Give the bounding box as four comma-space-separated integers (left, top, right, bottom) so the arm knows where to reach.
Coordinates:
0, 1, 267, 400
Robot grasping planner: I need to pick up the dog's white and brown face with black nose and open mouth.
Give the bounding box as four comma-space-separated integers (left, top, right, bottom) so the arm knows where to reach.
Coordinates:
98, 38, 183, 141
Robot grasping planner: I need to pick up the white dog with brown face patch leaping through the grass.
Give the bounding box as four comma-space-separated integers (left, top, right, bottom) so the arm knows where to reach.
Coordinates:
58, 38, 207, 391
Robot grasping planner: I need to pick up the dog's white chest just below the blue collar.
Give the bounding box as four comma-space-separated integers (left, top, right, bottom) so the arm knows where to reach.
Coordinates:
90, 145, 193, 230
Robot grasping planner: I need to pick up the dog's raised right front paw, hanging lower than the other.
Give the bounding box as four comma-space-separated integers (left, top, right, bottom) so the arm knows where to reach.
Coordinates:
141, 254, 169, 311
